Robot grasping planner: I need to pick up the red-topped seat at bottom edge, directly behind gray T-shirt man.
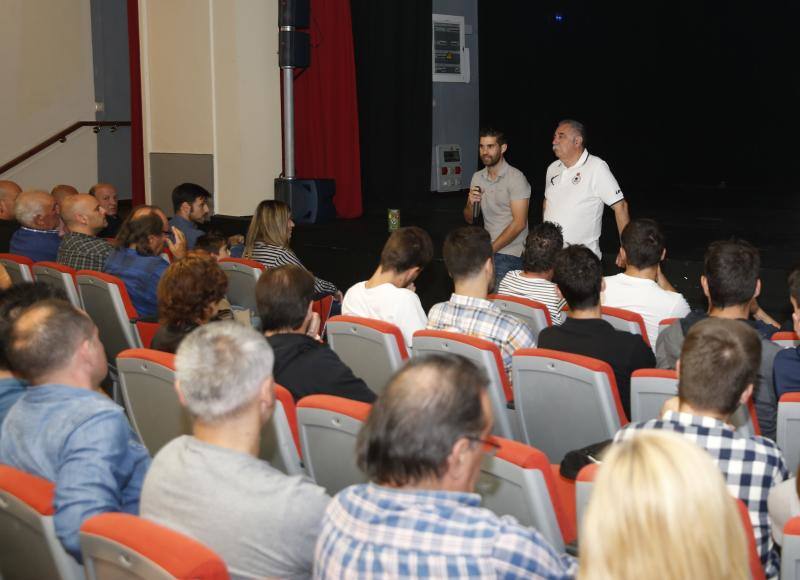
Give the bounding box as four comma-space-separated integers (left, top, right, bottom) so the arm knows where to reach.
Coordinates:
80, 513, 232, 580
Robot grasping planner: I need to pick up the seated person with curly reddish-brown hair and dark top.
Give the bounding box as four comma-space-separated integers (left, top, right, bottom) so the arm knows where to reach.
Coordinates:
150, 252, 228, 353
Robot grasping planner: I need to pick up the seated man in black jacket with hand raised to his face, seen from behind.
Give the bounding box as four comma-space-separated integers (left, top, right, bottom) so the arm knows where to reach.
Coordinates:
256, 264, 375, 403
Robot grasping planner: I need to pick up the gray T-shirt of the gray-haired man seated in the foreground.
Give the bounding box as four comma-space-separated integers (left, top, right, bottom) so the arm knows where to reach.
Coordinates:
140, 435, 330, 578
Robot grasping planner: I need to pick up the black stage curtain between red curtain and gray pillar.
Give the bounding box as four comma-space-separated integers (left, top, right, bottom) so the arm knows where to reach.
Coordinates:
350, 0, 432, 210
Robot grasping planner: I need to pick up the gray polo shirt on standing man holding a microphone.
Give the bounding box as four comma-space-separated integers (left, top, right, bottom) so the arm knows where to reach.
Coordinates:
470, 159, 531, 256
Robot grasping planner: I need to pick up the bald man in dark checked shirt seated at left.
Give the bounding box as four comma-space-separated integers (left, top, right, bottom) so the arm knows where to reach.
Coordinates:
58, 193, 114, 271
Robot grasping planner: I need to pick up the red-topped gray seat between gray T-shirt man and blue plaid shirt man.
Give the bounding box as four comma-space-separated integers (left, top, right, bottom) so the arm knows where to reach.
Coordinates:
297, 395, 372, 495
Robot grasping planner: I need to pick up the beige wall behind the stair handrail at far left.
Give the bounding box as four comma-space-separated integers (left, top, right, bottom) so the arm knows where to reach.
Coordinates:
0, 0, 97, 190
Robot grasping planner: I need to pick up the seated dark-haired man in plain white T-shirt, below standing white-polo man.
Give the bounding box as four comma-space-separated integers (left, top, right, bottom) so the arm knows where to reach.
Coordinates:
600, 219, 690, 349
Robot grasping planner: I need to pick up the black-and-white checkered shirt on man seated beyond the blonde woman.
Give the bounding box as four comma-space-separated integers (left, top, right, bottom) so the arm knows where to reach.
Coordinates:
614, 411, 789, 578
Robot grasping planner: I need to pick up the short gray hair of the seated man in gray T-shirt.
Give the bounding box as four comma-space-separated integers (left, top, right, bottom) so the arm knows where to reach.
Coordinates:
175, 321, 274, 422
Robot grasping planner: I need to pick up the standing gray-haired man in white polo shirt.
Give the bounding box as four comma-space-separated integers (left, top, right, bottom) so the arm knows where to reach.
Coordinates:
544, 119, 630, 260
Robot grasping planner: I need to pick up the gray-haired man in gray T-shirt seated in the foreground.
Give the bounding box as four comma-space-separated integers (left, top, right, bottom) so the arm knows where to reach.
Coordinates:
141, 321, 330, 578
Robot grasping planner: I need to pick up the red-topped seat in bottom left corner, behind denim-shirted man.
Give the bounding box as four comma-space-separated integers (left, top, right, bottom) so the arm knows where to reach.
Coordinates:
0, 465, 83, 580
